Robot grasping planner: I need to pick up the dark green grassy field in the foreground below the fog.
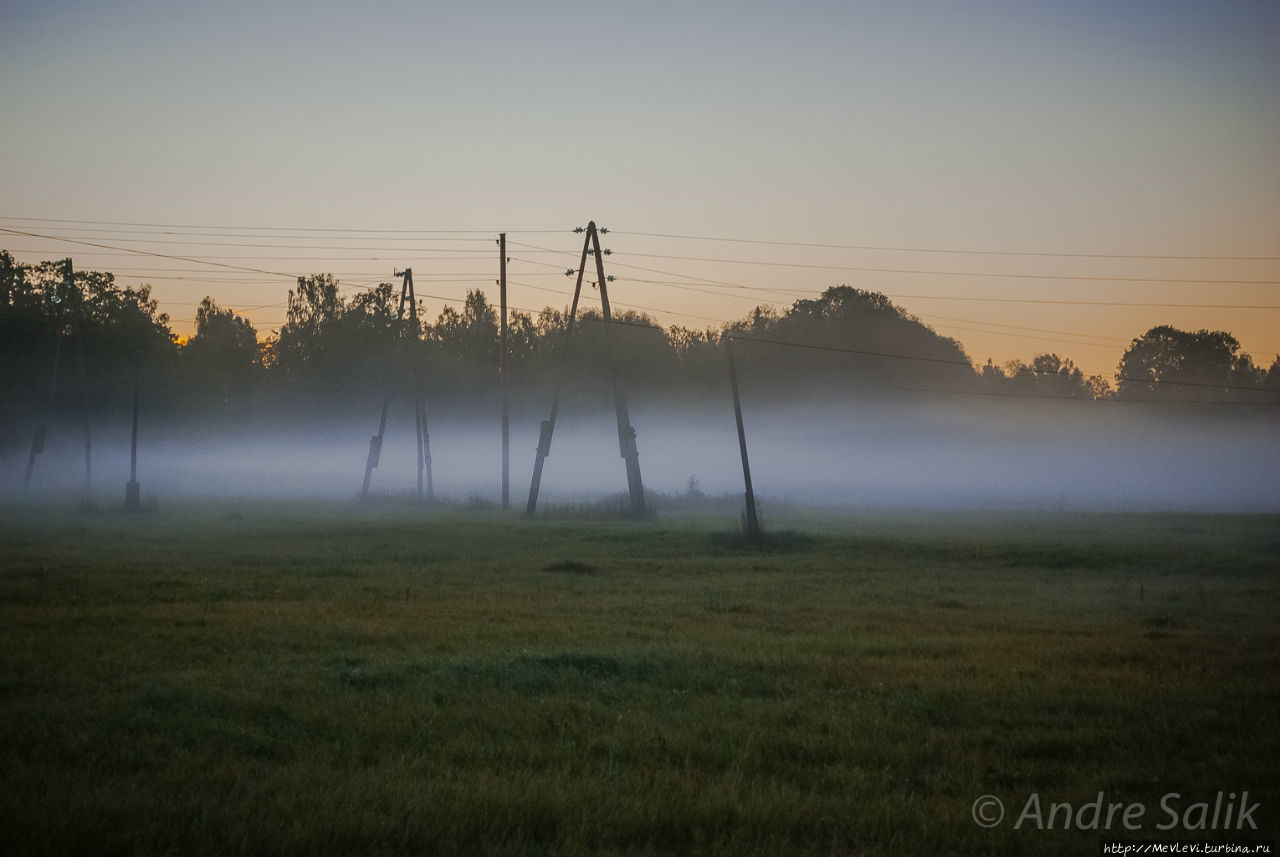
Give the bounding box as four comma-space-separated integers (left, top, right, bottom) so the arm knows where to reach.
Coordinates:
0, 505, 1280, 854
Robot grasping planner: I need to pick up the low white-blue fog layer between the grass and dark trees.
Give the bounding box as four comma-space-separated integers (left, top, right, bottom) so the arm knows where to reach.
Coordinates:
0, 395, 1280, 512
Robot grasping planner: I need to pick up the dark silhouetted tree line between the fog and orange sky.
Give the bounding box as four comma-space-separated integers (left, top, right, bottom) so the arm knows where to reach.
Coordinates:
0, 251, 1280, 437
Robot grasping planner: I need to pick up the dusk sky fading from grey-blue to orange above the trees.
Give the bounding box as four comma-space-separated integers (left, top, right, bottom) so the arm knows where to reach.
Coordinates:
0, 0, 1280, 377
